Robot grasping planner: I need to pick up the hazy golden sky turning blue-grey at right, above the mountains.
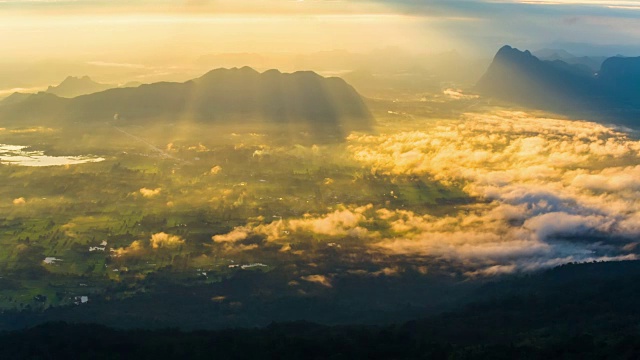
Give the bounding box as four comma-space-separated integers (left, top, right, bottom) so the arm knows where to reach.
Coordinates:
0, 0, 640, 91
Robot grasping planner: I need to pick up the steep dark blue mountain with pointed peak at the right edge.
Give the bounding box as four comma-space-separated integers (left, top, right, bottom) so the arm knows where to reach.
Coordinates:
476, 46, 640, 127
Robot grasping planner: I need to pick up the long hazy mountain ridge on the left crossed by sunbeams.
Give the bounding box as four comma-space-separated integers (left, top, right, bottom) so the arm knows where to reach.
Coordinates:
0, 67, 372, 136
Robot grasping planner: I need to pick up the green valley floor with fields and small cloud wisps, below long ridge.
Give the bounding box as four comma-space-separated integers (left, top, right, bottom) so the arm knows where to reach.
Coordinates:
0, 101, 476, 310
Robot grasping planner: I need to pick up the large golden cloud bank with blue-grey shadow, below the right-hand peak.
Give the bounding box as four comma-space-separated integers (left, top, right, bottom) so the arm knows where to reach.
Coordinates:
349, 111, 640, 276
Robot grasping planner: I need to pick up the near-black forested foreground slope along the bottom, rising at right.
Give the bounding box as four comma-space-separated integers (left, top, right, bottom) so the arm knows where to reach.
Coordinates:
0, 261, 640, 359
